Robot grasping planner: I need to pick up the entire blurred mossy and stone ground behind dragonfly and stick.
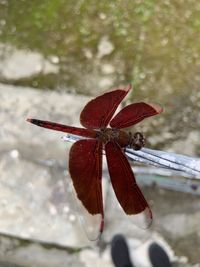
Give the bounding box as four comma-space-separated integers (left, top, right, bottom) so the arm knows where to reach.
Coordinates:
0, 0, 200, 267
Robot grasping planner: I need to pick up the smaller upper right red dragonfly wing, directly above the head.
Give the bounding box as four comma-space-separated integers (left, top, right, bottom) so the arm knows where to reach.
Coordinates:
110, 102, 163, 129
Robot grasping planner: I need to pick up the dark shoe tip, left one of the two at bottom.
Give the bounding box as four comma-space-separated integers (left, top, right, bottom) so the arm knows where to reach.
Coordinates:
111, 235, 134, 267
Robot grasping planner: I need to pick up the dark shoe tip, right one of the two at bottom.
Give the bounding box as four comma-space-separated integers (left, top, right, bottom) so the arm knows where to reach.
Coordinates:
149, 243, 172, 267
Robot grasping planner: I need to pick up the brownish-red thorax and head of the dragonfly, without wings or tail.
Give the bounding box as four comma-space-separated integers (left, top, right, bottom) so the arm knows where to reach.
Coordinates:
97, 128, 145, 150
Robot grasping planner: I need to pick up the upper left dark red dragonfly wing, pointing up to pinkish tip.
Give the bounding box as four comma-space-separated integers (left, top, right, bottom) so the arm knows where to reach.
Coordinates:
80, 86, 131, 129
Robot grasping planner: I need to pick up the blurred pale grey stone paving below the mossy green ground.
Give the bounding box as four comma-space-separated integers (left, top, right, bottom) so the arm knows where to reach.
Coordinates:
0, 84, 200, 267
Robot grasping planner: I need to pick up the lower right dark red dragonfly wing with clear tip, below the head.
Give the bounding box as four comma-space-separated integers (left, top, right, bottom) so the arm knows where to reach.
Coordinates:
105, 142, 152, 228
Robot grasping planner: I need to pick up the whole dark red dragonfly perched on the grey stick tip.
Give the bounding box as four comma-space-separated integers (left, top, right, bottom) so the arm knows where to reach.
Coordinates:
27, 85, 163, 239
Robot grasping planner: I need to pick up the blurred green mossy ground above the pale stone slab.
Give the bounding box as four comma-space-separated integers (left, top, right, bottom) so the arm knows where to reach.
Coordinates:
0, 0, 200, 99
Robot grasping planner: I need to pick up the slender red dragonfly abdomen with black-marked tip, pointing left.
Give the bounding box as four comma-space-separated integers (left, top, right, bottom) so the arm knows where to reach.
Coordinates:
27, 119, 96, 138
